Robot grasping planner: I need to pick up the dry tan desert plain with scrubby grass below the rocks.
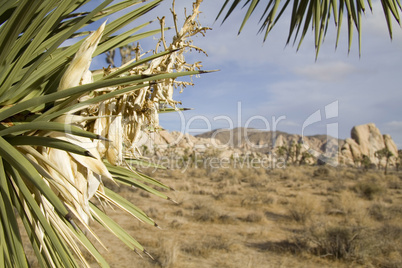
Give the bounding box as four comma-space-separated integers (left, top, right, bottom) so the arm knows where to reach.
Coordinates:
25, 166, 402, 268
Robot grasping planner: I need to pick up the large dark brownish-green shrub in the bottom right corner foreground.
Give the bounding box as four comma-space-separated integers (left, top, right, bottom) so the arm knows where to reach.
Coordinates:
289, 222, 402, 268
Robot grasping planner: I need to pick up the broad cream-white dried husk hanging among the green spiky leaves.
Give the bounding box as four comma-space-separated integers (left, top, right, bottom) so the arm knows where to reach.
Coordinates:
21, 23, 114, 245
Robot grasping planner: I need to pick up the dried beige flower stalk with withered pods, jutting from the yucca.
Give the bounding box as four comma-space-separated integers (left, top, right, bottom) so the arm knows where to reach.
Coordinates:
83, 0, 209, 159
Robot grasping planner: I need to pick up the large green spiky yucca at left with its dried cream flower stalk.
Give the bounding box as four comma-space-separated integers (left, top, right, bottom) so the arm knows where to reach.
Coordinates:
0, 0, 210, 267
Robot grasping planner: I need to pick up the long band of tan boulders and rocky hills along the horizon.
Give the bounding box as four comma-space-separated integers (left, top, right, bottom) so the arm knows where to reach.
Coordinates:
137, 123, 399, 166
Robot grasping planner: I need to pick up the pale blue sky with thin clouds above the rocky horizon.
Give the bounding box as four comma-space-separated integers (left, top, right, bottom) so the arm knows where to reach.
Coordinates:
90, 0, 402, 148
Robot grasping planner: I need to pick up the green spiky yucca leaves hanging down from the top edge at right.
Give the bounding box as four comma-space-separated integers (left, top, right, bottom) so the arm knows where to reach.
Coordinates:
217, 0, 402, 57
